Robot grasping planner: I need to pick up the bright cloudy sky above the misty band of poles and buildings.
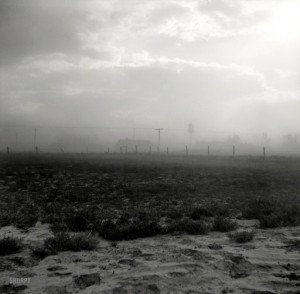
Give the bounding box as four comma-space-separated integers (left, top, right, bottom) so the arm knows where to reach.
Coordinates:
0, 0, 300, 139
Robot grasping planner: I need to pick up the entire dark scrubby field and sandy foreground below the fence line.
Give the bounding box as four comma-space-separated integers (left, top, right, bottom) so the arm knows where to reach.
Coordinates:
0, 154, 300, 294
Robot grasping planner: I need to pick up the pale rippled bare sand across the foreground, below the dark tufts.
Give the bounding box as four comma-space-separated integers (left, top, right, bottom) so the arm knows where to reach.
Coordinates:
0, 221, 300, 294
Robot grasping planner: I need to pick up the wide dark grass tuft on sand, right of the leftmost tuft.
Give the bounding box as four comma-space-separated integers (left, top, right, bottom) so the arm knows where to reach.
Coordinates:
44, 232, 98, 252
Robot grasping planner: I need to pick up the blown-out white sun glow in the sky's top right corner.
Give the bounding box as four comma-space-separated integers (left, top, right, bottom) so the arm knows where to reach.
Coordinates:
265, 1, 300, 41
